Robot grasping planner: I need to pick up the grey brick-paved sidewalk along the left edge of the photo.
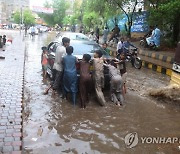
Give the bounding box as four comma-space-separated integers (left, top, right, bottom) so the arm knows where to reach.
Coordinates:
0, 32, 25, 154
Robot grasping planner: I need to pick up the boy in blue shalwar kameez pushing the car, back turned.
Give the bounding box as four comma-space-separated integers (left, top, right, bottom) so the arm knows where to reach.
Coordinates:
63, 46, 78, 105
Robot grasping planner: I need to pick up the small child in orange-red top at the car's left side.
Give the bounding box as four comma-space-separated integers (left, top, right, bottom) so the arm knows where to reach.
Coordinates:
41, 47, 48, 79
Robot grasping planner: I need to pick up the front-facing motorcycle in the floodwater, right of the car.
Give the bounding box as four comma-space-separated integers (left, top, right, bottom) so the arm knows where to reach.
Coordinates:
117, 47, 142, 69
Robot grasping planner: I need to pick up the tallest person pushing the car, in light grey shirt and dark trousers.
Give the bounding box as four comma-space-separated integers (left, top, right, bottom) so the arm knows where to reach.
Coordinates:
53, 37, 70, 95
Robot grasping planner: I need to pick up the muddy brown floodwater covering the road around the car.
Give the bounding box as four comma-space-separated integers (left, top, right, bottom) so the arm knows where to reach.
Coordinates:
23, 33, 180, 154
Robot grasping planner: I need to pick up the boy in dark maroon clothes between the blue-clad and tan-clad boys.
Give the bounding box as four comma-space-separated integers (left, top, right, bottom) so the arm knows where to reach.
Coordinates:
79, 54, 92, 108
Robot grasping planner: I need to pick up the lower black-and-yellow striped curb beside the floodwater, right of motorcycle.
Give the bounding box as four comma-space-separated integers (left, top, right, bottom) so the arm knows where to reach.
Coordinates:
142, 61, 172, 76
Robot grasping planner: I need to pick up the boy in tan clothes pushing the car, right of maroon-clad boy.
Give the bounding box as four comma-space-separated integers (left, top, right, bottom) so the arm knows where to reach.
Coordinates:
93, 50, 106, 106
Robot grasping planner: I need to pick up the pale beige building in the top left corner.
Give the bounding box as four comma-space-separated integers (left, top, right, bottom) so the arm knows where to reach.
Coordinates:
0, 0, 30, 24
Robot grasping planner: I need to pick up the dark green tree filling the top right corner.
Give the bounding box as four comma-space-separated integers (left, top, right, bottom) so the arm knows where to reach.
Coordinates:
149, 0, 180, 44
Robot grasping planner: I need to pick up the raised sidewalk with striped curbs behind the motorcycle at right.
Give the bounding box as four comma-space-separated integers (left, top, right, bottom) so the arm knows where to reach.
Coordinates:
108, 42, 175, 76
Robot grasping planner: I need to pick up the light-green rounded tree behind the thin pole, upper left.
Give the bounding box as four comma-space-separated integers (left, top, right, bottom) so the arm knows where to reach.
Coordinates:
13, 9, 35, 26
